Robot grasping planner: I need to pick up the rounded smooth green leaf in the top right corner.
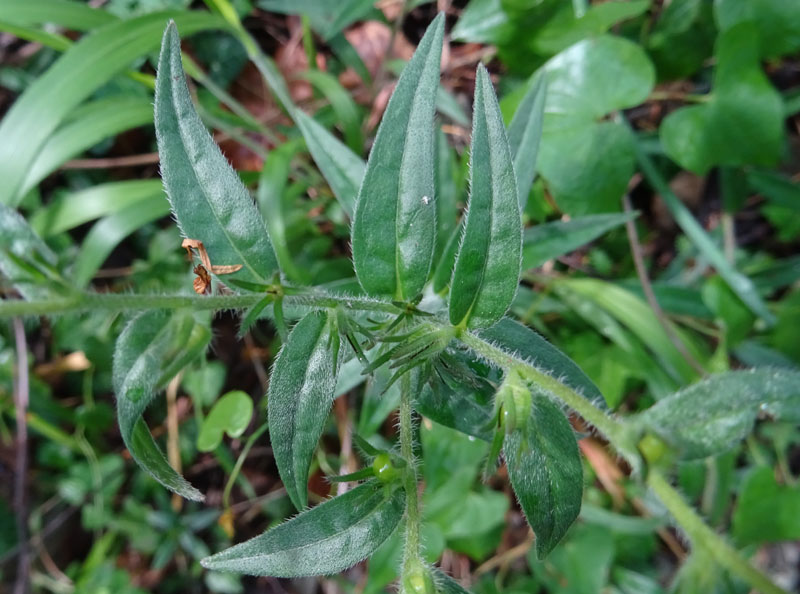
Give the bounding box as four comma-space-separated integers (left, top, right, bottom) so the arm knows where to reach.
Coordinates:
714, 0, 800, 58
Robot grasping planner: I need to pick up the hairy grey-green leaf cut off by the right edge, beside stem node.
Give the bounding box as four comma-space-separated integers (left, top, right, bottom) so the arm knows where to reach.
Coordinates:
639, 369, 800, 459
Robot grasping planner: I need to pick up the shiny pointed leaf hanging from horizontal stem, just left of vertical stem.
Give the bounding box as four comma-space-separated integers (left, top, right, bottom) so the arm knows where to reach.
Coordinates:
267, 311, 339, 509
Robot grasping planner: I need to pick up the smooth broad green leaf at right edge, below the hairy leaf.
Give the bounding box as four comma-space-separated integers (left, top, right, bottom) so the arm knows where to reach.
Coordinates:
733, 466, 800, 545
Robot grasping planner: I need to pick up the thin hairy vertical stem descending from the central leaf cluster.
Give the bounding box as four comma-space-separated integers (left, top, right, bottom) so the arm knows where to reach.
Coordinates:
400, 373, 421, 573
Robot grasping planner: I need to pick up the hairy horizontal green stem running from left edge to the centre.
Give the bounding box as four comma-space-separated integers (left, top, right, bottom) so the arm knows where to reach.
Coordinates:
0, 291, 402, 318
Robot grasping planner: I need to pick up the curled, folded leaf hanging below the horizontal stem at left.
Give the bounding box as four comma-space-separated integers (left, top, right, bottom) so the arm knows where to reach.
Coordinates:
113, 311, 211, 501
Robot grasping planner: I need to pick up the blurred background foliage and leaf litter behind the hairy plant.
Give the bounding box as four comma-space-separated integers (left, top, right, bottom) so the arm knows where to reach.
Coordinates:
0, 0, 800, 594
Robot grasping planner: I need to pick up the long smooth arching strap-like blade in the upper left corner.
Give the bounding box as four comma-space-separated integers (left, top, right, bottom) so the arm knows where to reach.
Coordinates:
0, 11, 226, 205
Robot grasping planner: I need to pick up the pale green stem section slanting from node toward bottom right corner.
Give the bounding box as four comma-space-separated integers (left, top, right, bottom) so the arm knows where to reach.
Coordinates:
647, 469, 787, 594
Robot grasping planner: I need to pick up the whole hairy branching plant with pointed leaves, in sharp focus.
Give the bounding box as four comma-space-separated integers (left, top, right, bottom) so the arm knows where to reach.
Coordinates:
0, 4, 800, 592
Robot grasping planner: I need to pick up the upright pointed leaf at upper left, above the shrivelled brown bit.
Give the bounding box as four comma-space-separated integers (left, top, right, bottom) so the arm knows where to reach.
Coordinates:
155, 23, 278, 283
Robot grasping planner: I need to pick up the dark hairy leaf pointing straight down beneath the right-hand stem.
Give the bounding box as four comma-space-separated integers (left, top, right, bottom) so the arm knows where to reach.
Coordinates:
503, 395, 583, 559
